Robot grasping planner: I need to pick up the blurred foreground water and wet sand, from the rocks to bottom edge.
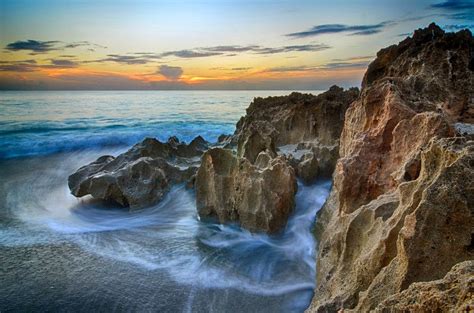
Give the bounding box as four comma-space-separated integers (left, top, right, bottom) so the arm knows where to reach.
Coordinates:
0, 151, 330, 312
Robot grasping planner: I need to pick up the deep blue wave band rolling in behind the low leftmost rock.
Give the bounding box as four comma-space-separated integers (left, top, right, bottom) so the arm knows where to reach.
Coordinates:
0, 121, 235, 160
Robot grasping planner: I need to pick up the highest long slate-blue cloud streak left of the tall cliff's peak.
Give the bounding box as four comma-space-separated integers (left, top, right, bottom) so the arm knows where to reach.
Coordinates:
286, 21, 396, 38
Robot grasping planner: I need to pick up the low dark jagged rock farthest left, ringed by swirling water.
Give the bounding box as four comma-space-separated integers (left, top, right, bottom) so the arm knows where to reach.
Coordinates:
68, 137, 208, 209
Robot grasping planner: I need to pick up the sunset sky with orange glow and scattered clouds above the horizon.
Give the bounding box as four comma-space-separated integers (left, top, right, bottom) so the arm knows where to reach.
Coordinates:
0, 0, 474, 90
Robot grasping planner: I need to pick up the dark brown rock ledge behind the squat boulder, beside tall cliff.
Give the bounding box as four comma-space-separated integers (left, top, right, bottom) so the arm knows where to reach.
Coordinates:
234, 86, 359, 183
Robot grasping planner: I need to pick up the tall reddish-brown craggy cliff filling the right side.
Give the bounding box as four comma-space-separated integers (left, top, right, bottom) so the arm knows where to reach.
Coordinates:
309, 24, 474, 312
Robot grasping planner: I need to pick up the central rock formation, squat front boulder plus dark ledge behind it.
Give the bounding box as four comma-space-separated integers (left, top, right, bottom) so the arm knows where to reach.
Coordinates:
195, 86, 358, 233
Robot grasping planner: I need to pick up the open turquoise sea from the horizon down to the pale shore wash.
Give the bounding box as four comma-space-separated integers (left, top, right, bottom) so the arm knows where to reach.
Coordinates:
0, 91, 317, 159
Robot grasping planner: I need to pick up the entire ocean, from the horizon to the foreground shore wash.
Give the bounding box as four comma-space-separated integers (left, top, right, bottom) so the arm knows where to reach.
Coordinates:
0, 91, 331, 312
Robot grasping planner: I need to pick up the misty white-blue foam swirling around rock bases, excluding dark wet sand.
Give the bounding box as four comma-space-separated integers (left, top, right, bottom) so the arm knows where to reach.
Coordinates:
0, 153, 331, 311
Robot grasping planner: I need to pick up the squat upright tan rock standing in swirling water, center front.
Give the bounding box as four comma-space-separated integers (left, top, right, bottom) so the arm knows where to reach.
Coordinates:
195, 148, 297, 233
